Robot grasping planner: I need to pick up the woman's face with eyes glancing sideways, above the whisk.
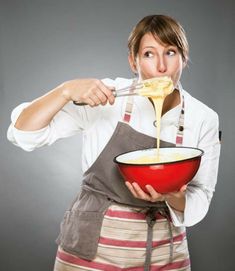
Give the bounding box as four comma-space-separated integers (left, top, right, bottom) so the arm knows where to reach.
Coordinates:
129, 33, 184, 86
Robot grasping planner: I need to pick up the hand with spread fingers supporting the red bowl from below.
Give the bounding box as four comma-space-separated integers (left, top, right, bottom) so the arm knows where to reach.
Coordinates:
125, 182, 187, 211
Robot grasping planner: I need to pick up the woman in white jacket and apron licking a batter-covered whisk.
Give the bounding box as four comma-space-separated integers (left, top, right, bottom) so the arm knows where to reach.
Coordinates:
8, 15, 220, 271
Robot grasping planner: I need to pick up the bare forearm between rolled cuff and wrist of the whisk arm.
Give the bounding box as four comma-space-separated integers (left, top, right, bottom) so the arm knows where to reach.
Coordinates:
15, 85, 69, 131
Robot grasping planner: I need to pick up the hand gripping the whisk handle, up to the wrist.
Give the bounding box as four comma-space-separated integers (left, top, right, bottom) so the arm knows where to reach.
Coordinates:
60, 79, 115, 107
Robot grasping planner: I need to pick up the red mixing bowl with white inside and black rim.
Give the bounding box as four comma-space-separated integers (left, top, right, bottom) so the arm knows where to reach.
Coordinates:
114, 147, 204, 194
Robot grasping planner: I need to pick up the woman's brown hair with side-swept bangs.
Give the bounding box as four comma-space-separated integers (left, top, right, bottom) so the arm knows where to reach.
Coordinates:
128, 15, 189, 63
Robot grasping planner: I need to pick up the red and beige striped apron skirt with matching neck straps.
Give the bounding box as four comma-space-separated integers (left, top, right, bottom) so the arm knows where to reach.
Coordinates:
54, 92, 191, 271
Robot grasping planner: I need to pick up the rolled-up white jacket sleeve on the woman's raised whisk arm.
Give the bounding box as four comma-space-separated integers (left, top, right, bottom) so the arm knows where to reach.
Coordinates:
7, 103, 98, 151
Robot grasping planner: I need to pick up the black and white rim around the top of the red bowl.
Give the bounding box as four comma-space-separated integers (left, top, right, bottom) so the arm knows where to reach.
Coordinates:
113, 146, 205, 167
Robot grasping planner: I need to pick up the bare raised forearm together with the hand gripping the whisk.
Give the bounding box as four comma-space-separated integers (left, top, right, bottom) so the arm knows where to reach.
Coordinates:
15, 79, 115, 131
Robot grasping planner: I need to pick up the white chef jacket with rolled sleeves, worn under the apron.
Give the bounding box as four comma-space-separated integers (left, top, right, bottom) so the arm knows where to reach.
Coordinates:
7, 78, 220, 226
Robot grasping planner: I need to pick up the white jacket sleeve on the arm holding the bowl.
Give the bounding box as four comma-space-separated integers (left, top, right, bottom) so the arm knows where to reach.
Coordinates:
167, 111, 220, 227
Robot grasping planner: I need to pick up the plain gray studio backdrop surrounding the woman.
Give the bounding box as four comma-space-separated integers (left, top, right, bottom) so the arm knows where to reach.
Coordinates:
0, 0, 235, 271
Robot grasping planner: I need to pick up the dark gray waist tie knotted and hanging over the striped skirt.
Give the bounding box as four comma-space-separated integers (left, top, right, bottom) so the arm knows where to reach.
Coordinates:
144, 207, 173, 271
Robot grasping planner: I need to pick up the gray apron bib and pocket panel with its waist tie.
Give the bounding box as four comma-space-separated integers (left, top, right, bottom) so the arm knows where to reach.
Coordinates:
56, 96, 185, 270
